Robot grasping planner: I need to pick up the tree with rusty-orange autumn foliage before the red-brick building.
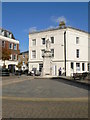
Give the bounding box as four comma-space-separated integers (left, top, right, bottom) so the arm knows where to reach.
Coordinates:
2, 47, 11, 68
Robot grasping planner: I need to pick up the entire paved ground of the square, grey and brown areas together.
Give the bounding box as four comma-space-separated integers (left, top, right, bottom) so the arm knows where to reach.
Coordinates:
0, 76, 88, 118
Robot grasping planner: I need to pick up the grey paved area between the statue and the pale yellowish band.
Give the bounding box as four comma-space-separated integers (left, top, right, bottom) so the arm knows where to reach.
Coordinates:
2, 79, 88, 98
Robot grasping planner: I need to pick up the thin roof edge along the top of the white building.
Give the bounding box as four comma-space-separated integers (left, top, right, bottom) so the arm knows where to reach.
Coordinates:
29, 26, 88, 34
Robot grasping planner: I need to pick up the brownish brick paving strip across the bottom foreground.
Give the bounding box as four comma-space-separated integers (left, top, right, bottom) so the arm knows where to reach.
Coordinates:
2, 100, 88, 118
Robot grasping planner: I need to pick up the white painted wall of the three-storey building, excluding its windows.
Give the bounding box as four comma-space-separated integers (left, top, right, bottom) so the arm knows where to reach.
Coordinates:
29, 28, 90, 76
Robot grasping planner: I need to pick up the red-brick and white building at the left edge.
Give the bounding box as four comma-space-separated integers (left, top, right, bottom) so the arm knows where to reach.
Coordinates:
0, 28, 20, 72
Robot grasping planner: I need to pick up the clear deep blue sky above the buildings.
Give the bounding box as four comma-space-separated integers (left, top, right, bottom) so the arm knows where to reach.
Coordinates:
2, 2, 88, 52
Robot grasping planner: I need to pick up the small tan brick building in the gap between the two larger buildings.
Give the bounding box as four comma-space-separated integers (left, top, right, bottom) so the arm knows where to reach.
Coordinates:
18, 51, 29, 71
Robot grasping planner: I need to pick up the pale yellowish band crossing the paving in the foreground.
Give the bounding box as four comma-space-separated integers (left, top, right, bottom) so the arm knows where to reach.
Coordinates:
0, 96, 88, 102
